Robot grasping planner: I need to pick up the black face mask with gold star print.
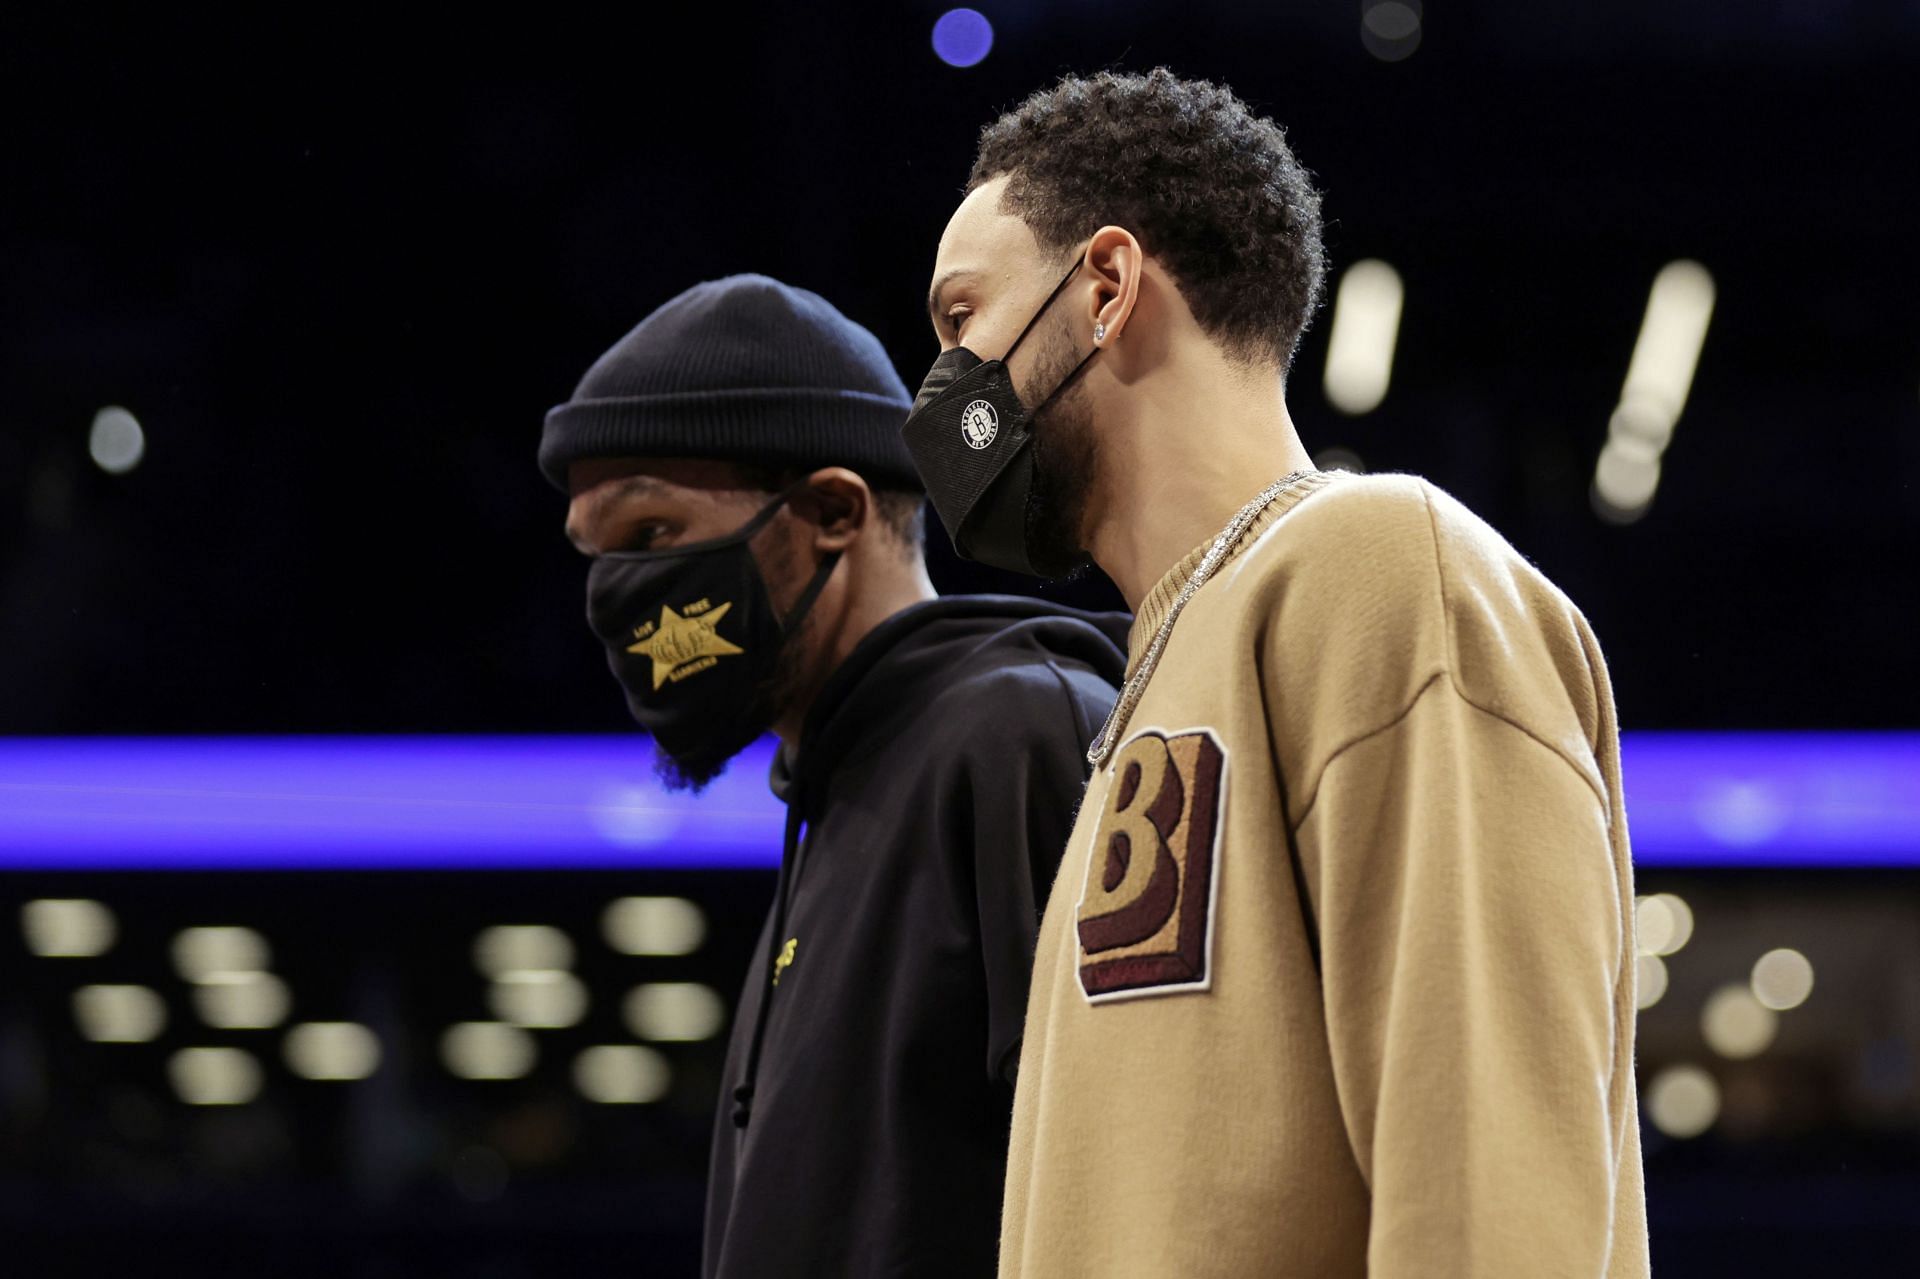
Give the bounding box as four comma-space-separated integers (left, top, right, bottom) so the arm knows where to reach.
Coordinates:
588, 495, 839, 778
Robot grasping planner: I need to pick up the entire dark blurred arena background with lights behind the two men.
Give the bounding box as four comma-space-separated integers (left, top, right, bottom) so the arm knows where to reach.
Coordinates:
0, 0, 1920, 1279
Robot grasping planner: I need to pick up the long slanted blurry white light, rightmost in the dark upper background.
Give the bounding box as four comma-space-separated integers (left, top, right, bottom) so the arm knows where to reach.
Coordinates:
1594, 261, 1715, 524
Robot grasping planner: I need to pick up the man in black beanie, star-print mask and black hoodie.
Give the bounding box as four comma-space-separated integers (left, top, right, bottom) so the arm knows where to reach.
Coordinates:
540, 275, 1125, 1279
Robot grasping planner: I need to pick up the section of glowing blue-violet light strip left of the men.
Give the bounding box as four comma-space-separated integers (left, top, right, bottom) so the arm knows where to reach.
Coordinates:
0, 736, 785, 870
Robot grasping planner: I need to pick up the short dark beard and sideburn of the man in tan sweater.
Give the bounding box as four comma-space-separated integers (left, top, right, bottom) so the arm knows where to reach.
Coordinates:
1021, 325, 1094, 580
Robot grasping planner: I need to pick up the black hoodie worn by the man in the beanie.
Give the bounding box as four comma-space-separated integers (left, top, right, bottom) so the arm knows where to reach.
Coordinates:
705, 595, 1127, 1279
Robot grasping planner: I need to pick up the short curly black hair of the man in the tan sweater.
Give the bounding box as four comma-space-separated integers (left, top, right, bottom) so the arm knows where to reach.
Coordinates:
966, 67, 1327, 369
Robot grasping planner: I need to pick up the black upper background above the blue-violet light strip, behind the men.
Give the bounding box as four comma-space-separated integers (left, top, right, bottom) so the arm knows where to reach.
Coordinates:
0, 0, 1920, 734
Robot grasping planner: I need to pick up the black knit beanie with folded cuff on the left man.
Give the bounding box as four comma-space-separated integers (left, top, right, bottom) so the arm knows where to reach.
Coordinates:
540, 275, 922, 492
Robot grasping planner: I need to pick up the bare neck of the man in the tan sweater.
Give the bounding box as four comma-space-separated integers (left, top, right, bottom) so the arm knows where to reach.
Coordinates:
1087, 355, 1313, 613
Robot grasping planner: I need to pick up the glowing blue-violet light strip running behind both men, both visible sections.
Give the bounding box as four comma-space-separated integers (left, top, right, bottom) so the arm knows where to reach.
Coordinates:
0, 734, 1920, 870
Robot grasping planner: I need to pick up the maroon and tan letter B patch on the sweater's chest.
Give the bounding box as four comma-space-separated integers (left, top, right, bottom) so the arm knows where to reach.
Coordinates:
1075, 728, 1227, 1002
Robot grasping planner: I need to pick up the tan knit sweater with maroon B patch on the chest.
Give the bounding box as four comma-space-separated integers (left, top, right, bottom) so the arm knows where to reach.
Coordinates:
1000, 476, 1647, 1279
